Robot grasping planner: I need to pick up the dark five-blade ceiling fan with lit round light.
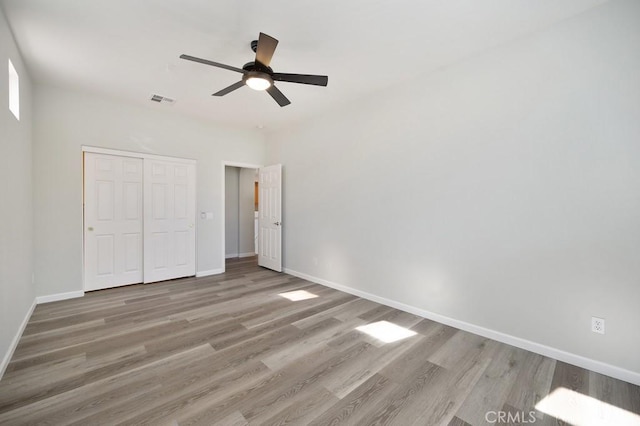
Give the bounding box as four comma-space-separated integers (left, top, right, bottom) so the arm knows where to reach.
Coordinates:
180, 33, 329, 107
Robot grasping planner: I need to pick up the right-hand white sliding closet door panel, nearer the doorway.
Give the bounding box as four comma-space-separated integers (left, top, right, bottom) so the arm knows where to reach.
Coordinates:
144, 158, 196, 283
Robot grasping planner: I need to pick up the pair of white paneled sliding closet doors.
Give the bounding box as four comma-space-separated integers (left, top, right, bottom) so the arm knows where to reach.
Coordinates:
84, 152, 196, 291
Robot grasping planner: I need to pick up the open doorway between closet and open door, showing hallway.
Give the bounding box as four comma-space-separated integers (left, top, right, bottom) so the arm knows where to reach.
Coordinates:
224, 164, 259, 262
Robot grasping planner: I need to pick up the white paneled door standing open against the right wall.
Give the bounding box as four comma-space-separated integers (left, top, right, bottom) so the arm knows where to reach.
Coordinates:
258, 164, 282, 272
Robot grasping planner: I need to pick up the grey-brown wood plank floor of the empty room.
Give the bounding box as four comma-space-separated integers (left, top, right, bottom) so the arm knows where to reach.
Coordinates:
0, 258, 640, 425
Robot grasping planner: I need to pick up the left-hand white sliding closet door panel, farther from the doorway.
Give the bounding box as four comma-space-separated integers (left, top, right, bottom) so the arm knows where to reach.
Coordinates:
84, 152, 143, 291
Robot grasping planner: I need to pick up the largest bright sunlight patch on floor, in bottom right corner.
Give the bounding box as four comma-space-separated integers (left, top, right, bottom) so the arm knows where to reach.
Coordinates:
536, 387, 640, 426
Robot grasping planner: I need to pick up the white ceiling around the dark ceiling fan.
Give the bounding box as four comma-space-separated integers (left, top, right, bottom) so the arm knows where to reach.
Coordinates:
0, 0, 606, 129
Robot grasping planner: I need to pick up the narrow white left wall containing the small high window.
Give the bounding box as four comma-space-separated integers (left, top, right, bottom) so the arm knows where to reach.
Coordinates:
0, 9, 35, 377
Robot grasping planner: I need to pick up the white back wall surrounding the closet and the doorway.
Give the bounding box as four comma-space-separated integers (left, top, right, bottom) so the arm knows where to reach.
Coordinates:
34, 86, 265, 296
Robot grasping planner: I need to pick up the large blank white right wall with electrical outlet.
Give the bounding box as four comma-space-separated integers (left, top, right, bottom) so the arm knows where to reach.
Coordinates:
269, 0, 640, 379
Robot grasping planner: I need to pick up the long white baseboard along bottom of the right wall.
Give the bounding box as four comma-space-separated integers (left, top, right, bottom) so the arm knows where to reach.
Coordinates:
284, 268, 640, 386
